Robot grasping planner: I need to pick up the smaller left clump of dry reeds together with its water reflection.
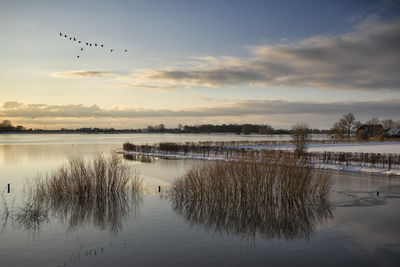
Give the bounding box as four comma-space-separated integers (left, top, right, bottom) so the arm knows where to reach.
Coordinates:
21, 153, 142, 234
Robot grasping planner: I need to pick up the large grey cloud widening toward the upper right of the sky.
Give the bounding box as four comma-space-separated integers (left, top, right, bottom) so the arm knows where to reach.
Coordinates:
142, 16, 400, 91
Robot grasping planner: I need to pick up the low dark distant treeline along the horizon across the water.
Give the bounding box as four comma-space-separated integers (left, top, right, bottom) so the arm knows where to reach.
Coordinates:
0, 120, 329, 134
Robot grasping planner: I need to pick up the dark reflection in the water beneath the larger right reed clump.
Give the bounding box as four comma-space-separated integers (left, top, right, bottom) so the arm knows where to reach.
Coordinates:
172, 193, 333, 240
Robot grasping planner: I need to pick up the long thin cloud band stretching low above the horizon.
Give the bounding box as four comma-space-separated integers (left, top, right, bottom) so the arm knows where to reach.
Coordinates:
0, 99, 400, 118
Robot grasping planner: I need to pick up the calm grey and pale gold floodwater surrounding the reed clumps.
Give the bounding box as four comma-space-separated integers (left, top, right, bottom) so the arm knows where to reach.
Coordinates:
0, 135, 400, 267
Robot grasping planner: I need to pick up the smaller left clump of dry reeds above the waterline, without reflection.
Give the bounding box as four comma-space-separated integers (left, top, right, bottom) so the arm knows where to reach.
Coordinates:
31, 153, 141, 201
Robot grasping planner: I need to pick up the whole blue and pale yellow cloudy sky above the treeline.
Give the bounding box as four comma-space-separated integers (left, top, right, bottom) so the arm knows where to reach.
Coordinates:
0, 0, 400, 129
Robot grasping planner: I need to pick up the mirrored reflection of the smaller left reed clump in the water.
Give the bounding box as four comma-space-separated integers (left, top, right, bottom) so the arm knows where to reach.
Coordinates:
2, 193, 142, 238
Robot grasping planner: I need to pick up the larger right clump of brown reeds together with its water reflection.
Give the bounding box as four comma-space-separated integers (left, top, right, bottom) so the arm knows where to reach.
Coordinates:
170, 154, 332, 240
